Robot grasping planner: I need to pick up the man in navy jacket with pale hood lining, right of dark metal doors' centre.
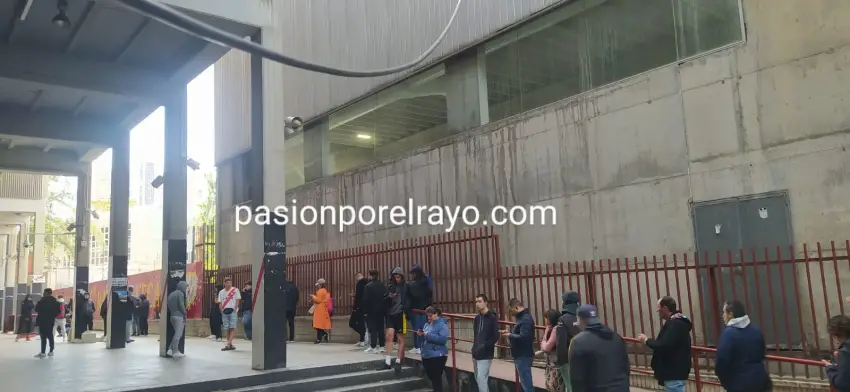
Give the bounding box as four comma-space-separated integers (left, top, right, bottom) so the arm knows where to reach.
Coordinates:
714, 301, 771, 392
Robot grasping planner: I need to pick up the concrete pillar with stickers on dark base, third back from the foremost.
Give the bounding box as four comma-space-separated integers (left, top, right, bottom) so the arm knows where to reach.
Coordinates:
106, 130, 131, 348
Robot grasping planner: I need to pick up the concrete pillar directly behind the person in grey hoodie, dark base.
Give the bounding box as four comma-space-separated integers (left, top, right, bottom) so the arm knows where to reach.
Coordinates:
159, 86, 188, 357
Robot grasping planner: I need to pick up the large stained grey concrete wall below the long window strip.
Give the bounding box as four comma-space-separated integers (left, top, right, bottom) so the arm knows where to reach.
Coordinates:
214, 0, 850, 347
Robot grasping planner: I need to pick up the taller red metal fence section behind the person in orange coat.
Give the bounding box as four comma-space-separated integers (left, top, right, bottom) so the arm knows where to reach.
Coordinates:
287, 228, 502, 316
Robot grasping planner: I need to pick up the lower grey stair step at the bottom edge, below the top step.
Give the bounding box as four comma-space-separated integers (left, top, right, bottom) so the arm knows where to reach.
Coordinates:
219, 367, 416, 392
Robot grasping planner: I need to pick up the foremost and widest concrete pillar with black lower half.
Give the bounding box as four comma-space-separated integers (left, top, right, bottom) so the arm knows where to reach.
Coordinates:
250, 27, 290, 370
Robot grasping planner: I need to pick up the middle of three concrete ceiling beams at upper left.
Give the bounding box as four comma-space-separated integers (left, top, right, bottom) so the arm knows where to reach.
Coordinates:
0, 105, 122, 146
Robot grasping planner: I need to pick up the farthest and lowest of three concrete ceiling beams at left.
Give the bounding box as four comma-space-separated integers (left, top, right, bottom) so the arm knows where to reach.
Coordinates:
0, 147, 84, 176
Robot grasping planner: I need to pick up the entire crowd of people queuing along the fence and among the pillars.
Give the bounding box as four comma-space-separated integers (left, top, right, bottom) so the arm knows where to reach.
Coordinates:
11, 265, 850, 392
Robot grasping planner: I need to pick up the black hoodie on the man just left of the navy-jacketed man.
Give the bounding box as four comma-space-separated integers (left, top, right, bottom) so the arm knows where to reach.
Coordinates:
646, 311, 692, 385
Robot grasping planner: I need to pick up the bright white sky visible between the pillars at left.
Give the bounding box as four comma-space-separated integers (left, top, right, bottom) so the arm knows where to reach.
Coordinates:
92, 66, 215, 173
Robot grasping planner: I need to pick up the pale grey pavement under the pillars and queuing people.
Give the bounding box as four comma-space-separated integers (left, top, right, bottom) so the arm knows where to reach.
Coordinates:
0, 334, 645, 392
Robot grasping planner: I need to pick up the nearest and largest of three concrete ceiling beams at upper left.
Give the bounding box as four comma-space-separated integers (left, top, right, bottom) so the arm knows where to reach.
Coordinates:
0, 45, 171, 104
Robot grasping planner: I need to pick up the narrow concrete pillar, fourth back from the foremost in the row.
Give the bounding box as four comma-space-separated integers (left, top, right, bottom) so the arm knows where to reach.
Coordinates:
69, 164, 91, 340
